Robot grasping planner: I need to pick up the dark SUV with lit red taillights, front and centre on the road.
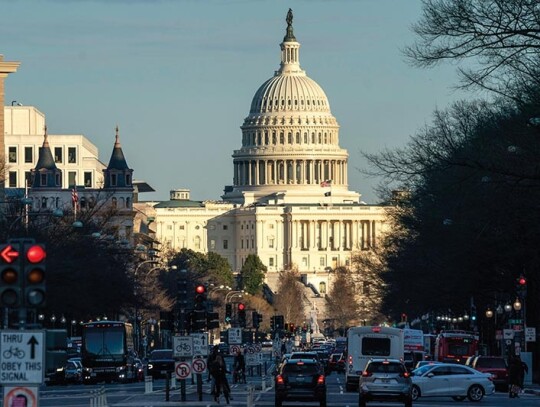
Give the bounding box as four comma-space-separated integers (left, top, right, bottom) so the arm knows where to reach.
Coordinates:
274, 359, 326, 407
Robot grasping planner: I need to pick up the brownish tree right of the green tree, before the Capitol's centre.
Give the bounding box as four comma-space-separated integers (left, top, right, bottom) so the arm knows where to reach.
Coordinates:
274, 270, 306, 326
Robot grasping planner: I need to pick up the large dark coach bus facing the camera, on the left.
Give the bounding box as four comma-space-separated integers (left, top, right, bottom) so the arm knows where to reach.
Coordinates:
81, 321, 137, 384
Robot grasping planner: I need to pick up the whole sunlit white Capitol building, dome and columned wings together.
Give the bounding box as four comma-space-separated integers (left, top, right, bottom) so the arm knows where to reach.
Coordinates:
148, 12, 386, 304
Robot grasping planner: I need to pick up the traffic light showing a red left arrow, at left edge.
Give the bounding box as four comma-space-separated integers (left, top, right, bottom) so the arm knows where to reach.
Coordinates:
0, 243, 23, 308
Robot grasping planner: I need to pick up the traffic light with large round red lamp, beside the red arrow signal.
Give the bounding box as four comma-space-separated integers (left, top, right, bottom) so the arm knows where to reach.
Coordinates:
22, 242, 47, 308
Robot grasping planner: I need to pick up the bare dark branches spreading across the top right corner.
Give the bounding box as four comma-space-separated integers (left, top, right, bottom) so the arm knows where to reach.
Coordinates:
405, 0, 540, 98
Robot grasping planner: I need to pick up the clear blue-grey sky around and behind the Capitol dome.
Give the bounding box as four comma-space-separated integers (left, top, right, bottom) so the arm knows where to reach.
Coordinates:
0, 0, 461, 203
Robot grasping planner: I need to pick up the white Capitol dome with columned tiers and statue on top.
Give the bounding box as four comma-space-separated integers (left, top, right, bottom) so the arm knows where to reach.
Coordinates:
222, 10, 359, 204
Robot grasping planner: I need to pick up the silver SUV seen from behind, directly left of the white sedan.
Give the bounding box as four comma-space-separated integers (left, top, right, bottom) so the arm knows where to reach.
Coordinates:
358, 359, 412, 407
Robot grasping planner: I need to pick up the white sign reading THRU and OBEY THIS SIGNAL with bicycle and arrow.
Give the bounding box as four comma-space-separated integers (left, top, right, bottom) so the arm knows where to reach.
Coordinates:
0, 330, 45, 385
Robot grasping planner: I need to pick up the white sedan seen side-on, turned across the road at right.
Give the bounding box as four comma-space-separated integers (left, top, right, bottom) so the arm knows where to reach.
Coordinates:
412, 363, 495, 401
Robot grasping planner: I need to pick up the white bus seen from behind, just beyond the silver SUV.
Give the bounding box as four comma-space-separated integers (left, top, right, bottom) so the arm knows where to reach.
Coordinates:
345, 326, 404, 391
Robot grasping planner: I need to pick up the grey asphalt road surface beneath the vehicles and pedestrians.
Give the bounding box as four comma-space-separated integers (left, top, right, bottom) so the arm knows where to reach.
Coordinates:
40, 373, 540, 407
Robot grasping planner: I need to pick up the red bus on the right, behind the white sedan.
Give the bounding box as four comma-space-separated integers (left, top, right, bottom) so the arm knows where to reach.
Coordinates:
435, 330, 478, 364
